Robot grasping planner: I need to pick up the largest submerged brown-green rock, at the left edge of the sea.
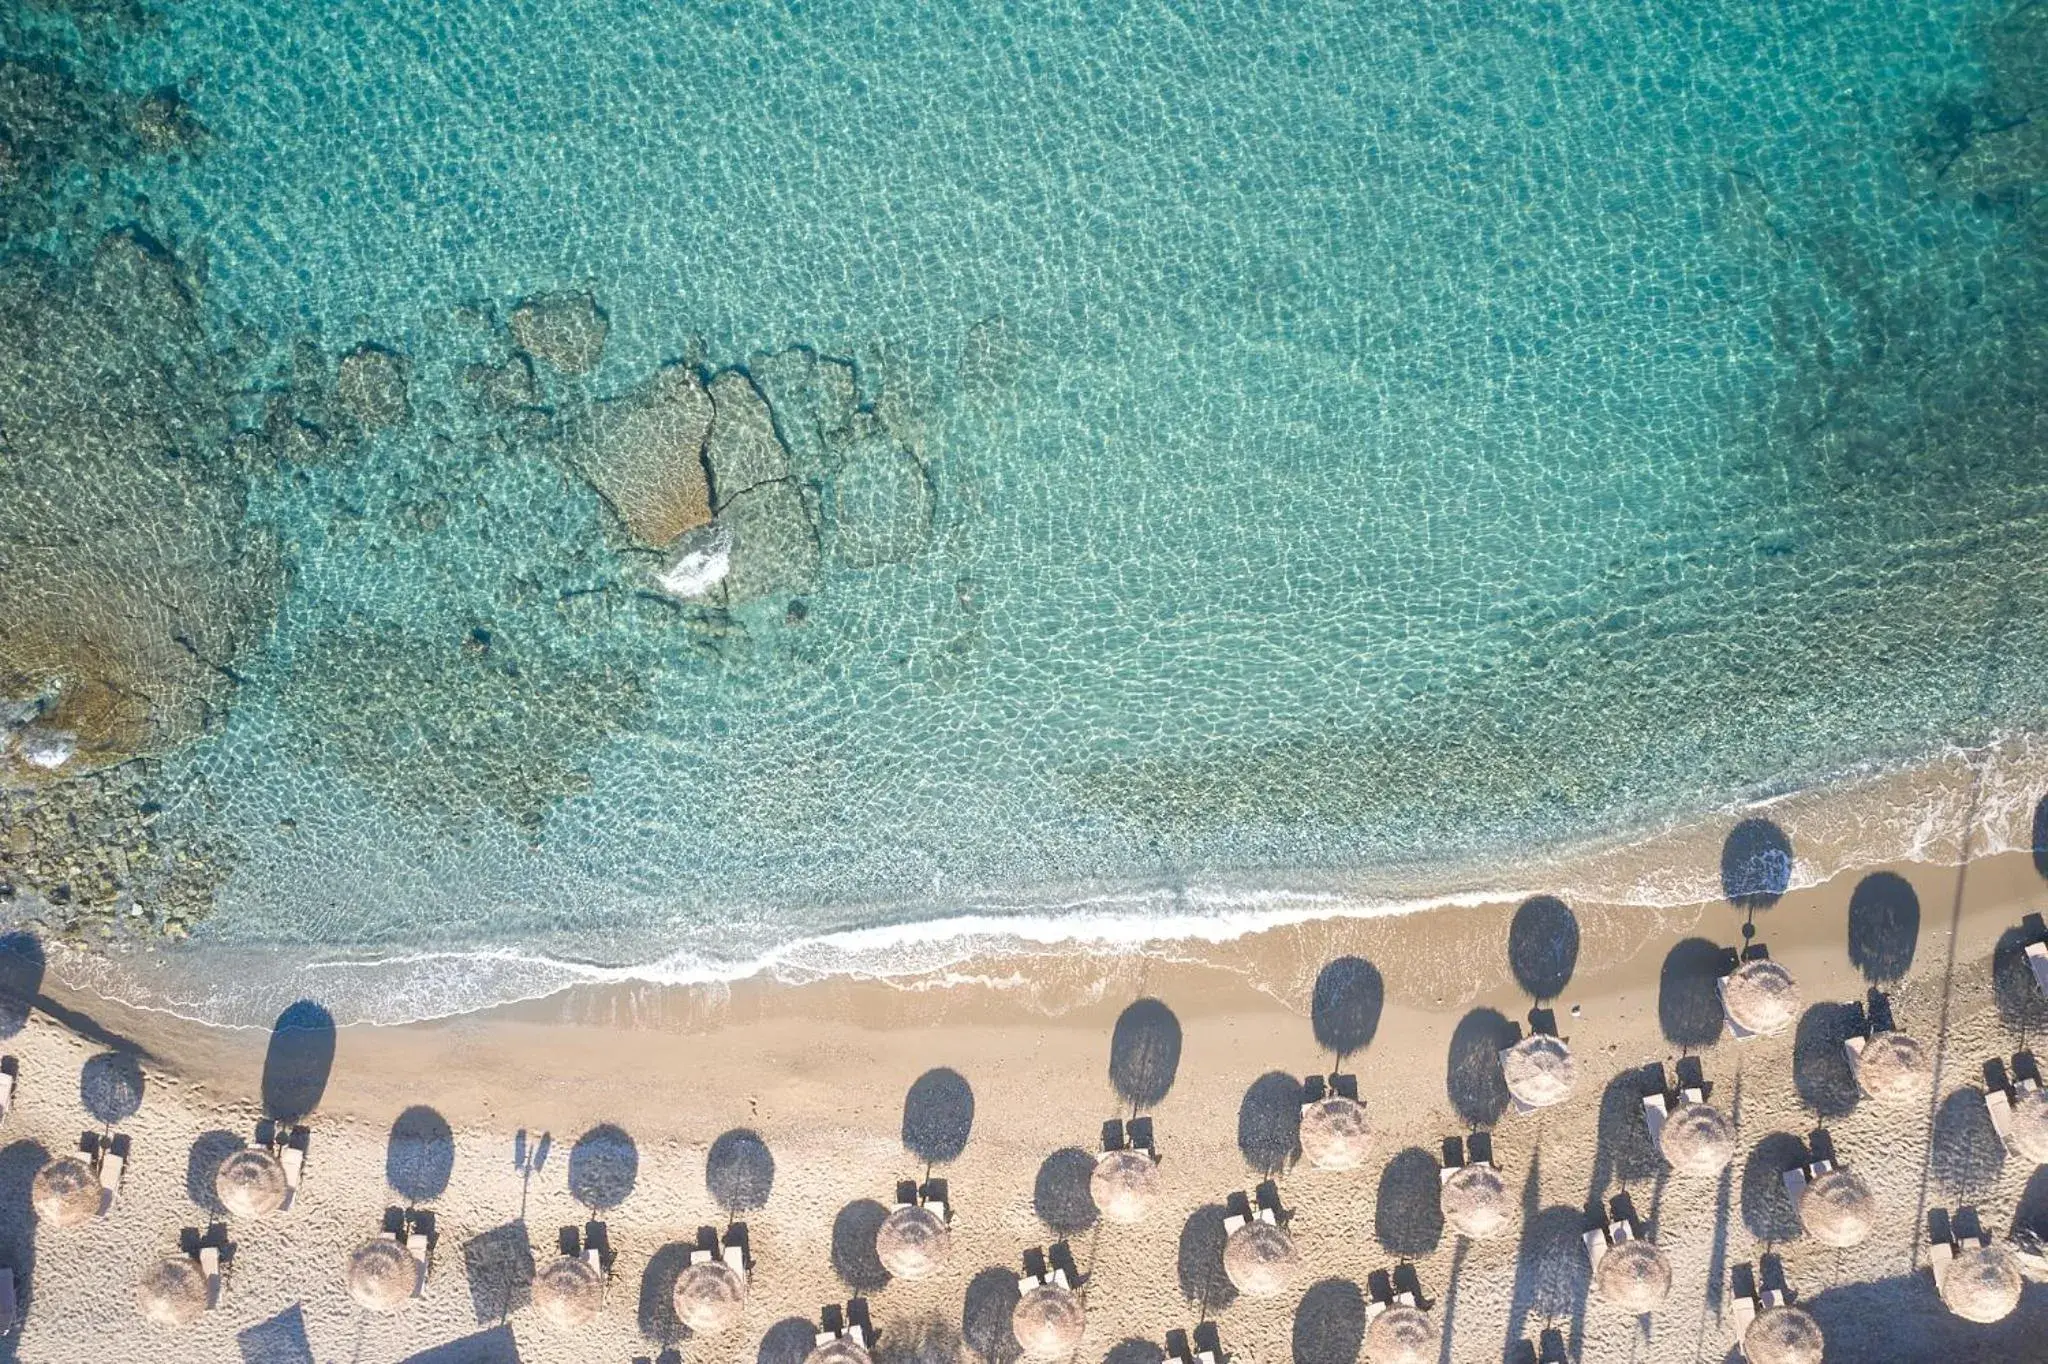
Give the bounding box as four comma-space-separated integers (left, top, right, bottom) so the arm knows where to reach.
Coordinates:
0, 229, 279, 786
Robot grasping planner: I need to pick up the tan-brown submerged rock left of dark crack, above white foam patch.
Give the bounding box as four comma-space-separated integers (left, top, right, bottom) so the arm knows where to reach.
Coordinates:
561, 365, 713, 549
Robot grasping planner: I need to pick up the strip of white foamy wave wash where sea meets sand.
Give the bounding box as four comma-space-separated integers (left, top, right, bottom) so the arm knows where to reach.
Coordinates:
36, 733, 2048, 1028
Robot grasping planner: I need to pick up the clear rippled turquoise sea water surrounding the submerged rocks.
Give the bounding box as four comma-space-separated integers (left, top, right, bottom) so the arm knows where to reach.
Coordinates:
4, 0, 2048, 1019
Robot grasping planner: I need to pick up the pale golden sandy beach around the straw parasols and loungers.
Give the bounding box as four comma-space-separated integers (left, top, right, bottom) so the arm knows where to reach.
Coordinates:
0, 753, 2048, 1364
